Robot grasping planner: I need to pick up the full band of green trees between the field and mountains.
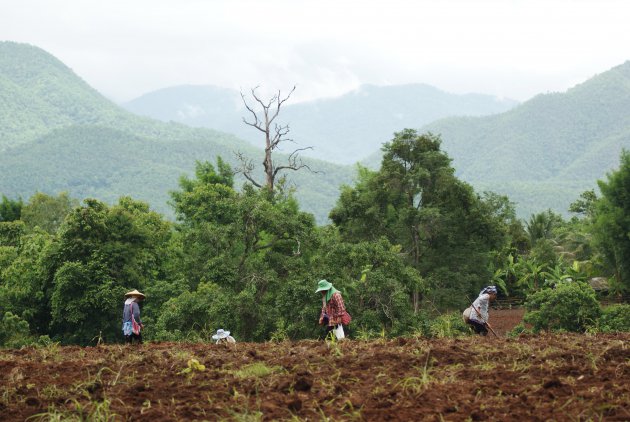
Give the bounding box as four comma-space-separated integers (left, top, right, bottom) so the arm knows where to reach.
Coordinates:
0, 129, 630, 345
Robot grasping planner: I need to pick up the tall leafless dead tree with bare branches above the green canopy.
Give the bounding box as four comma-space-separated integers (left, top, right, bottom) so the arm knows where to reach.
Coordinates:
236, 86, 312, 191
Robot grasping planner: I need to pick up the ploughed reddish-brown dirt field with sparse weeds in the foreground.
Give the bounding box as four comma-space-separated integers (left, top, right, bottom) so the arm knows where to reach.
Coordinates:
0, 326, 630, 421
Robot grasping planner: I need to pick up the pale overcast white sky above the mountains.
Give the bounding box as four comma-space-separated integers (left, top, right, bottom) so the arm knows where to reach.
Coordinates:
0, 0, 630, 101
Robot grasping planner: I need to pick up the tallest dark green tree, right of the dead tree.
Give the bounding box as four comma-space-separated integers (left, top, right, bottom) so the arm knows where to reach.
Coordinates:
330, 129, 506, 312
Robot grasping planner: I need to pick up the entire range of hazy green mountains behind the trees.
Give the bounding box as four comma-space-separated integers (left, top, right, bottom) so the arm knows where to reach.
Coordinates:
0, 42, 630, 223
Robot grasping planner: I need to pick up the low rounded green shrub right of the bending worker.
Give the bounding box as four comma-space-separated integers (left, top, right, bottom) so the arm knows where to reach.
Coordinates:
523, 282, 601, 332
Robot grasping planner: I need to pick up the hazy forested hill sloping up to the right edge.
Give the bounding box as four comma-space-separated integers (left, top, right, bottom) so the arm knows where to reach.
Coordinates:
366, 62, 630, 217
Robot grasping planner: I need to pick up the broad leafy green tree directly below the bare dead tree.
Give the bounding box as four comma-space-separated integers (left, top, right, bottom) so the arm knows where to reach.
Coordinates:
169, 158, 317, 340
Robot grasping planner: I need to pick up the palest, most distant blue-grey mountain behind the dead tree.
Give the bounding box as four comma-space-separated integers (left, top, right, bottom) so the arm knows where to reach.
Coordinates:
124, 84, 516, 164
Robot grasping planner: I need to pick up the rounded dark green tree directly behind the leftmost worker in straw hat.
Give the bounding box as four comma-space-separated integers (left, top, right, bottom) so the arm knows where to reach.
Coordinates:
50, 197, 170, 344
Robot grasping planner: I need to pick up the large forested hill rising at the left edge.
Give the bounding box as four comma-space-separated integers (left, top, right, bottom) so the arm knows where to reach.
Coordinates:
0, 42, 354, 222
